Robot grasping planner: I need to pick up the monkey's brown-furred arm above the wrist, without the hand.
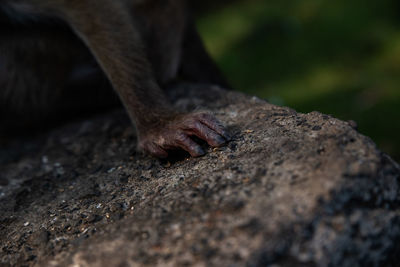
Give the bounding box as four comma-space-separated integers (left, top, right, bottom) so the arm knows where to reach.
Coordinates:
27, 0, 172, 125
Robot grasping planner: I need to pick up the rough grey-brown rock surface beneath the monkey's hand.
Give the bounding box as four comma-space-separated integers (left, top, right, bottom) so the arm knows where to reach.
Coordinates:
0, 86, 400, 267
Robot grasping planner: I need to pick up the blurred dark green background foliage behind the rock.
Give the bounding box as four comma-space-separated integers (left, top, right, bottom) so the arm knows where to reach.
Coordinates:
196, 0, 400, 162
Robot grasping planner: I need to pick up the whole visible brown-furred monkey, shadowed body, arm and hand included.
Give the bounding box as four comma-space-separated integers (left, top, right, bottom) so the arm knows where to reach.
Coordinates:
0, 0, 229, 157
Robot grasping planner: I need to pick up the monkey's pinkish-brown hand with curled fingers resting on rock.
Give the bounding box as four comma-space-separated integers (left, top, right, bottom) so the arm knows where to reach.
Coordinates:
139, 112, 230, 158
